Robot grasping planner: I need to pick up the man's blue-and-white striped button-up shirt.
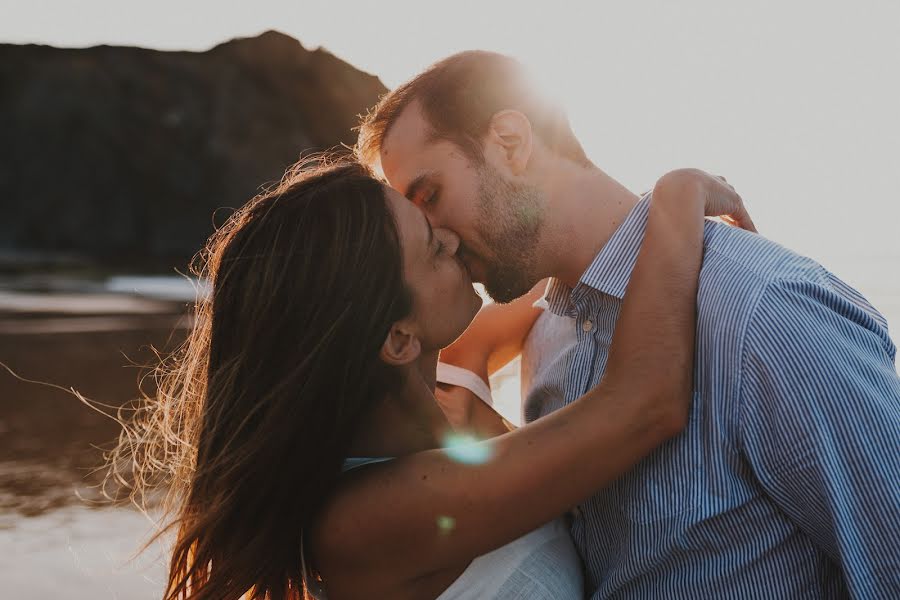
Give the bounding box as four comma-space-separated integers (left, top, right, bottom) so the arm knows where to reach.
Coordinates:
526, 198, 900, 599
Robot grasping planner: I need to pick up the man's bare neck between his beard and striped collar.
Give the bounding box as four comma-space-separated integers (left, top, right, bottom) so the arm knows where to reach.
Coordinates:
545, 162, 639, 288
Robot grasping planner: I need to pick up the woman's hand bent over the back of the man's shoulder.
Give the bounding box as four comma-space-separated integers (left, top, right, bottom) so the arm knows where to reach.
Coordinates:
653, 169, 756, 233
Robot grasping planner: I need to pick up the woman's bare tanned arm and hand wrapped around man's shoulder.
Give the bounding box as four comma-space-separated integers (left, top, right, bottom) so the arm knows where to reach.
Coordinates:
316, 171, 743, 584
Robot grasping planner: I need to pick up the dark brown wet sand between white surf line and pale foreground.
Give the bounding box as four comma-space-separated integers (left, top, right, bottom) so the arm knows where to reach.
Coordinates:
0, 315, 184, 524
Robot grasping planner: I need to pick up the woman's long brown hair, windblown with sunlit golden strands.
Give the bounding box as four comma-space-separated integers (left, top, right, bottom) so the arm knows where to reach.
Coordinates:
112, 162, 412, 600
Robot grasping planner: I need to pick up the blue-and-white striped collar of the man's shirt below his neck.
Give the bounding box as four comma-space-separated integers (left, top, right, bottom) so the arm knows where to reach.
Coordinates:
545, 194, 650, 317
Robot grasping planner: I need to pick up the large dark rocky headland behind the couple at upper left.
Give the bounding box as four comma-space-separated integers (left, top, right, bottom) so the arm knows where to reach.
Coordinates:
0, 32, 385, 268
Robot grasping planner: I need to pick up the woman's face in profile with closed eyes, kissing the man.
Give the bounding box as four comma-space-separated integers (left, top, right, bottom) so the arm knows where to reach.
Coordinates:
385, 187, 482, 351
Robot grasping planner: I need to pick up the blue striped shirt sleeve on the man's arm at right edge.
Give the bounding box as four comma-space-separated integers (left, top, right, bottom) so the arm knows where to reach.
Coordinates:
739, 283, 900, 598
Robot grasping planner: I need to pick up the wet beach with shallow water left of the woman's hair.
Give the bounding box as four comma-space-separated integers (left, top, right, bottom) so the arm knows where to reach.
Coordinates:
0, 291, 190, 600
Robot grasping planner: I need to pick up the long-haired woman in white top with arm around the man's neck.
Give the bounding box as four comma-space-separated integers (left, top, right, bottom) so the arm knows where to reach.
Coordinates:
120, 157, 742, 600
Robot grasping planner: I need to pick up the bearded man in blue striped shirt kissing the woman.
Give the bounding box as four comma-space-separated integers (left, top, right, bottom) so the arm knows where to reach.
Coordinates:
358, 52, 900, 598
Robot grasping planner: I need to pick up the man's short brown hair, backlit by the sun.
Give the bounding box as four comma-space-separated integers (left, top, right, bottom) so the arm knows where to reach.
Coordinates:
355, 50, 591, 170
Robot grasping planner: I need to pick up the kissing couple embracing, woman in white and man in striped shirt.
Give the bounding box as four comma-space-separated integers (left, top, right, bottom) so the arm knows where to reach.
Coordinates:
134, 51, 900, 600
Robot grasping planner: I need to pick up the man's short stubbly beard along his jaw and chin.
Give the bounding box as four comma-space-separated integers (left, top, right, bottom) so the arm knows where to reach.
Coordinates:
476, 165, 544, 304
